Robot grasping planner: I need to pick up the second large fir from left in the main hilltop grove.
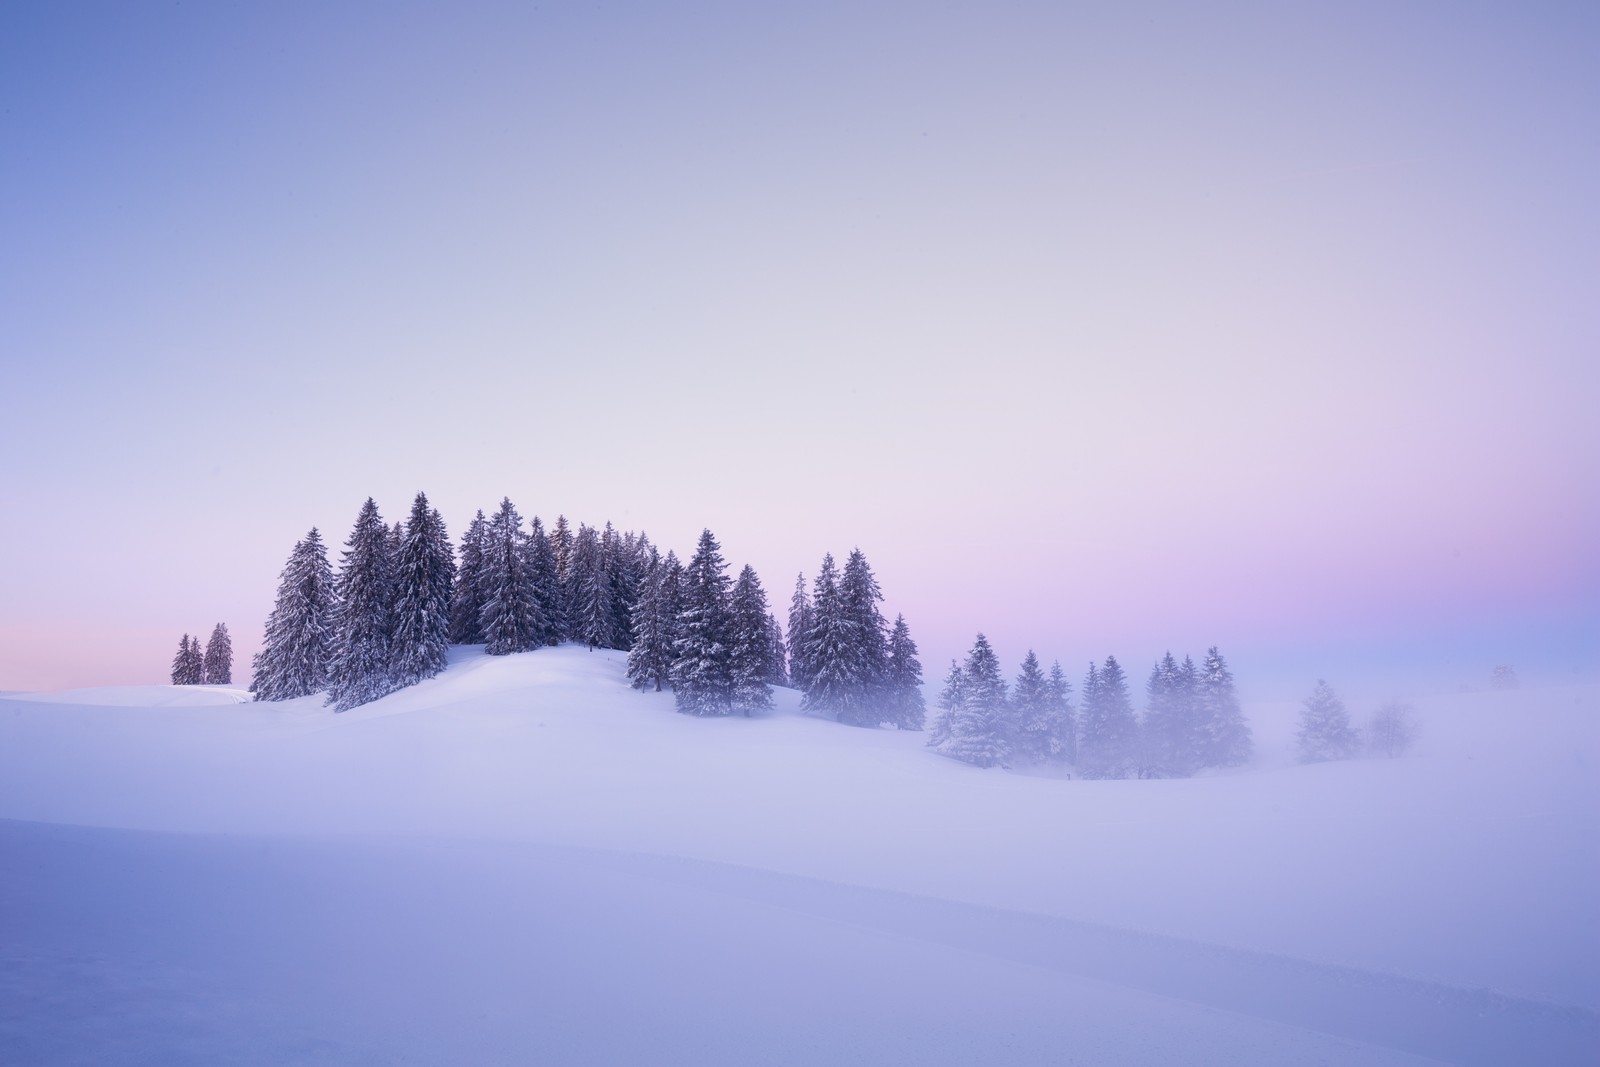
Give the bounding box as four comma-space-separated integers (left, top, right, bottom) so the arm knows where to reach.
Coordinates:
328, 498, 395, 712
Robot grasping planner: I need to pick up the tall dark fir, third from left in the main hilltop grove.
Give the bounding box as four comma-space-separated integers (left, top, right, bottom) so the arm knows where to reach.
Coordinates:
389, 493, 454, 689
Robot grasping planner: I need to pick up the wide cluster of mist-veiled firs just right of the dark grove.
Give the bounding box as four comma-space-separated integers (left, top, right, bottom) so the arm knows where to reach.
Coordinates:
928, 633, 1251, 777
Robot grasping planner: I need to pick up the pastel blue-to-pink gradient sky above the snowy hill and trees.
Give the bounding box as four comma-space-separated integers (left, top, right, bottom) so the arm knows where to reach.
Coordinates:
0, 2, 1600, 699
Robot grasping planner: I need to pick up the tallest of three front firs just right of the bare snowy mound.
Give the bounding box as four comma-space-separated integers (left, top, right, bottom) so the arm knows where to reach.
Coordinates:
672, 530, 733, 715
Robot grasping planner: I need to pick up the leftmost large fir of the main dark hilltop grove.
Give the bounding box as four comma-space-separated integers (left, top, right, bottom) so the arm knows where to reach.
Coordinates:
250, 528, 338, 701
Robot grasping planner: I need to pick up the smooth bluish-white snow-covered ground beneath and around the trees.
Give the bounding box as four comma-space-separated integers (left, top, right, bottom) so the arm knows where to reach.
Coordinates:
0, 646, 1600, 1064
